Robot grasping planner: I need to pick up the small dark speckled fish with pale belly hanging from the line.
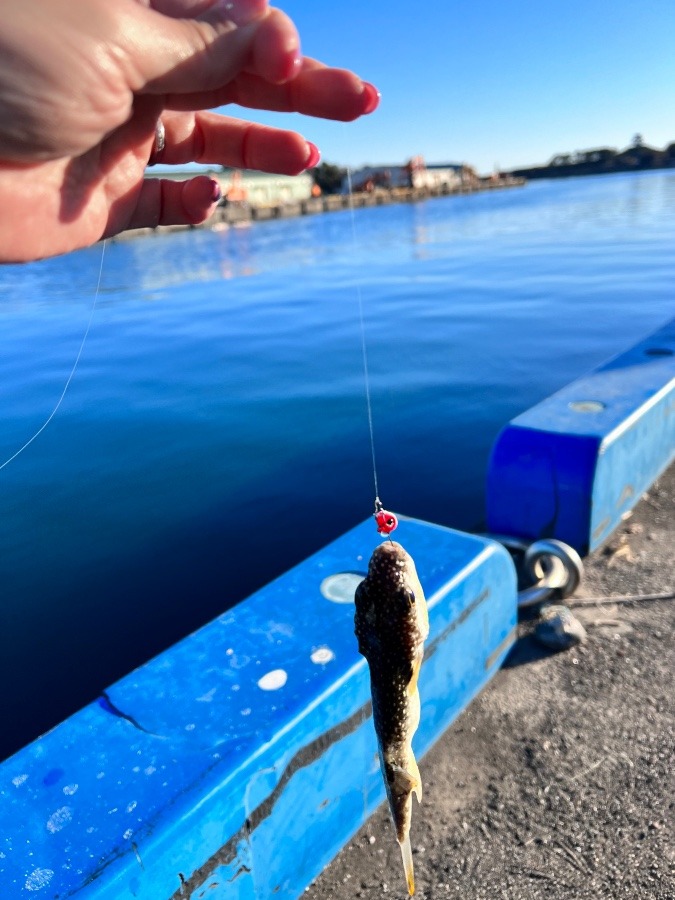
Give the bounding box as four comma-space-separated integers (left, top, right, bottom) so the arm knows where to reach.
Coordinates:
354, 540, 429, 894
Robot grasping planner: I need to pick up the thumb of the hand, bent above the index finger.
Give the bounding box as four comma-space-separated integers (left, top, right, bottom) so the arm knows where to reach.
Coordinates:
119, 2, 301, 94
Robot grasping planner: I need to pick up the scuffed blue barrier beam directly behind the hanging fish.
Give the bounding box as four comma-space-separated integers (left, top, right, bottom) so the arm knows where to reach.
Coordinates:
0, 519, 517, 900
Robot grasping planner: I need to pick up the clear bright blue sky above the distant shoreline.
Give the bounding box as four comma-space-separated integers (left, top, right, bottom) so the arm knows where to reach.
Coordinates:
219, 0, 675, 173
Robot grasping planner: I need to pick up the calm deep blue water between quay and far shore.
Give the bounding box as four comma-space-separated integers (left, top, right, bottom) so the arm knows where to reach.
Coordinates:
0, 172, 675, 754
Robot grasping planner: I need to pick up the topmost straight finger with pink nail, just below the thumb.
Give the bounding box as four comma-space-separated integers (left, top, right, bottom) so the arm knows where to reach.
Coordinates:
166, 57, 380, 122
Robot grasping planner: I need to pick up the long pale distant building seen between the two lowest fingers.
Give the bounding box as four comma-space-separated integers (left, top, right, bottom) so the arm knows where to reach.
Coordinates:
147, 168, 314, 208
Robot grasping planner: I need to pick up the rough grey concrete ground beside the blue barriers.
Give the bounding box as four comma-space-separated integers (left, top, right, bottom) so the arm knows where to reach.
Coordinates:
305, 466, 675, 900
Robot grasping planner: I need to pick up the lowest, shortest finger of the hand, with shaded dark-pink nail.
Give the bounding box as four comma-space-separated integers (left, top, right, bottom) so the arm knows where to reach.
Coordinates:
116, 175, 221, 237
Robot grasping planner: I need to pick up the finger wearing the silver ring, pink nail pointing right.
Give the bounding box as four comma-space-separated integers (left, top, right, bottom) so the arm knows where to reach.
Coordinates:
154, 112, 319, 175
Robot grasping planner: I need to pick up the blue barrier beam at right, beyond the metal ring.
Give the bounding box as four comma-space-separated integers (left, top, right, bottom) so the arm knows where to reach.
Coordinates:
487, 319, 675, 553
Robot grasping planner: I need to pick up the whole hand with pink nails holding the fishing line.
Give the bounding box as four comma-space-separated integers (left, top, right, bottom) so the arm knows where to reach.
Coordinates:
0, 0, 378, 262
